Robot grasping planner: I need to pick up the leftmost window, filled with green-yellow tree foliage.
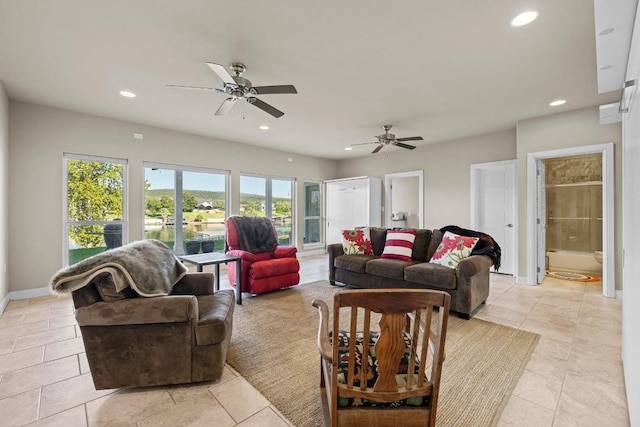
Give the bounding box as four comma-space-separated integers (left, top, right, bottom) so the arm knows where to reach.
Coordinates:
64, 154, 127, 265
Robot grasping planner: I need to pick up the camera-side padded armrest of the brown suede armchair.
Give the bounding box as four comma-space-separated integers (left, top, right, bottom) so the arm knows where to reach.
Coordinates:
76, 295, 198, 326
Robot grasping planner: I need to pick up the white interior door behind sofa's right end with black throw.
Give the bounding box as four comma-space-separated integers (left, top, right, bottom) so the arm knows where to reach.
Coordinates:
471, 161, 516, 275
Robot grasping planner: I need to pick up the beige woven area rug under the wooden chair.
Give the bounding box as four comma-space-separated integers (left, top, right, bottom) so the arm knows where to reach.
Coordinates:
227, 281, 539, 427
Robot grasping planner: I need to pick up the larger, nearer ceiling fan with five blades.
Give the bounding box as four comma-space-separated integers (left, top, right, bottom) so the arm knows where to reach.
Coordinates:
167, 62, 298, 118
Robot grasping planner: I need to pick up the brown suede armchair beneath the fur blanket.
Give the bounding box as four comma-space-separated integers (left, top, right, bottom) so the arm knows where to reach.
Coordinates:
72, 273, 234, 389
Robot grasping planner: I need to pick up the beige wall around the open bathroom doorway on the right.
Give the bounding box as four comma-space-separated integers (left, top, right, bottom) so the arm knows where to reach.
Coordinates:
516, 106, 622, 289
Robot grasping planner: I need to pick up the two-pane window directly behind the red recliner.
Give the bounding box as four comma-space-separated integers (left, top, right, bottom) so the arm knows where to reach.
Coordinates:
240, 175, 295, 245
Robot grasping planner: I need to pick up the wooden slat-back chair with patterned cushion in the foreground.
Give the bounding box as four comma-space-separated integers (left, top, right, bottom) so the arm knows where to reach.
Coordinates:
312, 289, 451, 426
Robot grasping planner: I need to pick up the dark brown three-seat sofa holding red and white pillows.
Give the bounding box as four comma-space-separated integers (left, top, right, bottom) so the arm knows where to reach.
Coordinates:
327, 227, 493, 319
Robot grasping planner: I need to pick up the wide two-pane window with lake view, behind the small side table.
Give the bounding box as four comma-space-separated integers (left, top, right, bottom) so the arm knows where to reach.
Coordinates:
144, 163, 229, 254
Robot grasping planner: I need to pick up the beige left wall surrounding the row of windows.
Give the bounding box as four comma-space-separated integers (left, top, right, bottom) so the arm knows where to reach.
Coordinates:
9, 101, 337, 291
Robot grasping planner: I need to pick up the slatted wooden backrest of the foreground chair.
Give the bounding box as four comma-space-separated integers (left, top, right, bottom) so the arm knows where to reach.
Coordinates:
331, 289, 451, 425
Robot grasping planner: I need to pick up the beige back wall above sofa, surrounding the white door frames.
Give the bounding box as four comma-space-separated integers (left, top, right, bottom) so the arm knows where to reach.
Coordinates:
338, 129, 516, 229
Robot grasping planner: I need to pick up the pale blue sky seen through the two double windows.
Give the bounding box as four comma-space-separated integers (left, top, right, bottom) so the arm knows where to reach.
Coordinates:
145, 168, 291, 197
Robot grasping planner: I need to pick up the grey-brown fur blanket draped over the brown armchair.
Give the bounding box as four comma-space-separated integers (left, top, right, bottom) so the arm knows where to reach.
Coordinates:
50, 239, 187, 297
